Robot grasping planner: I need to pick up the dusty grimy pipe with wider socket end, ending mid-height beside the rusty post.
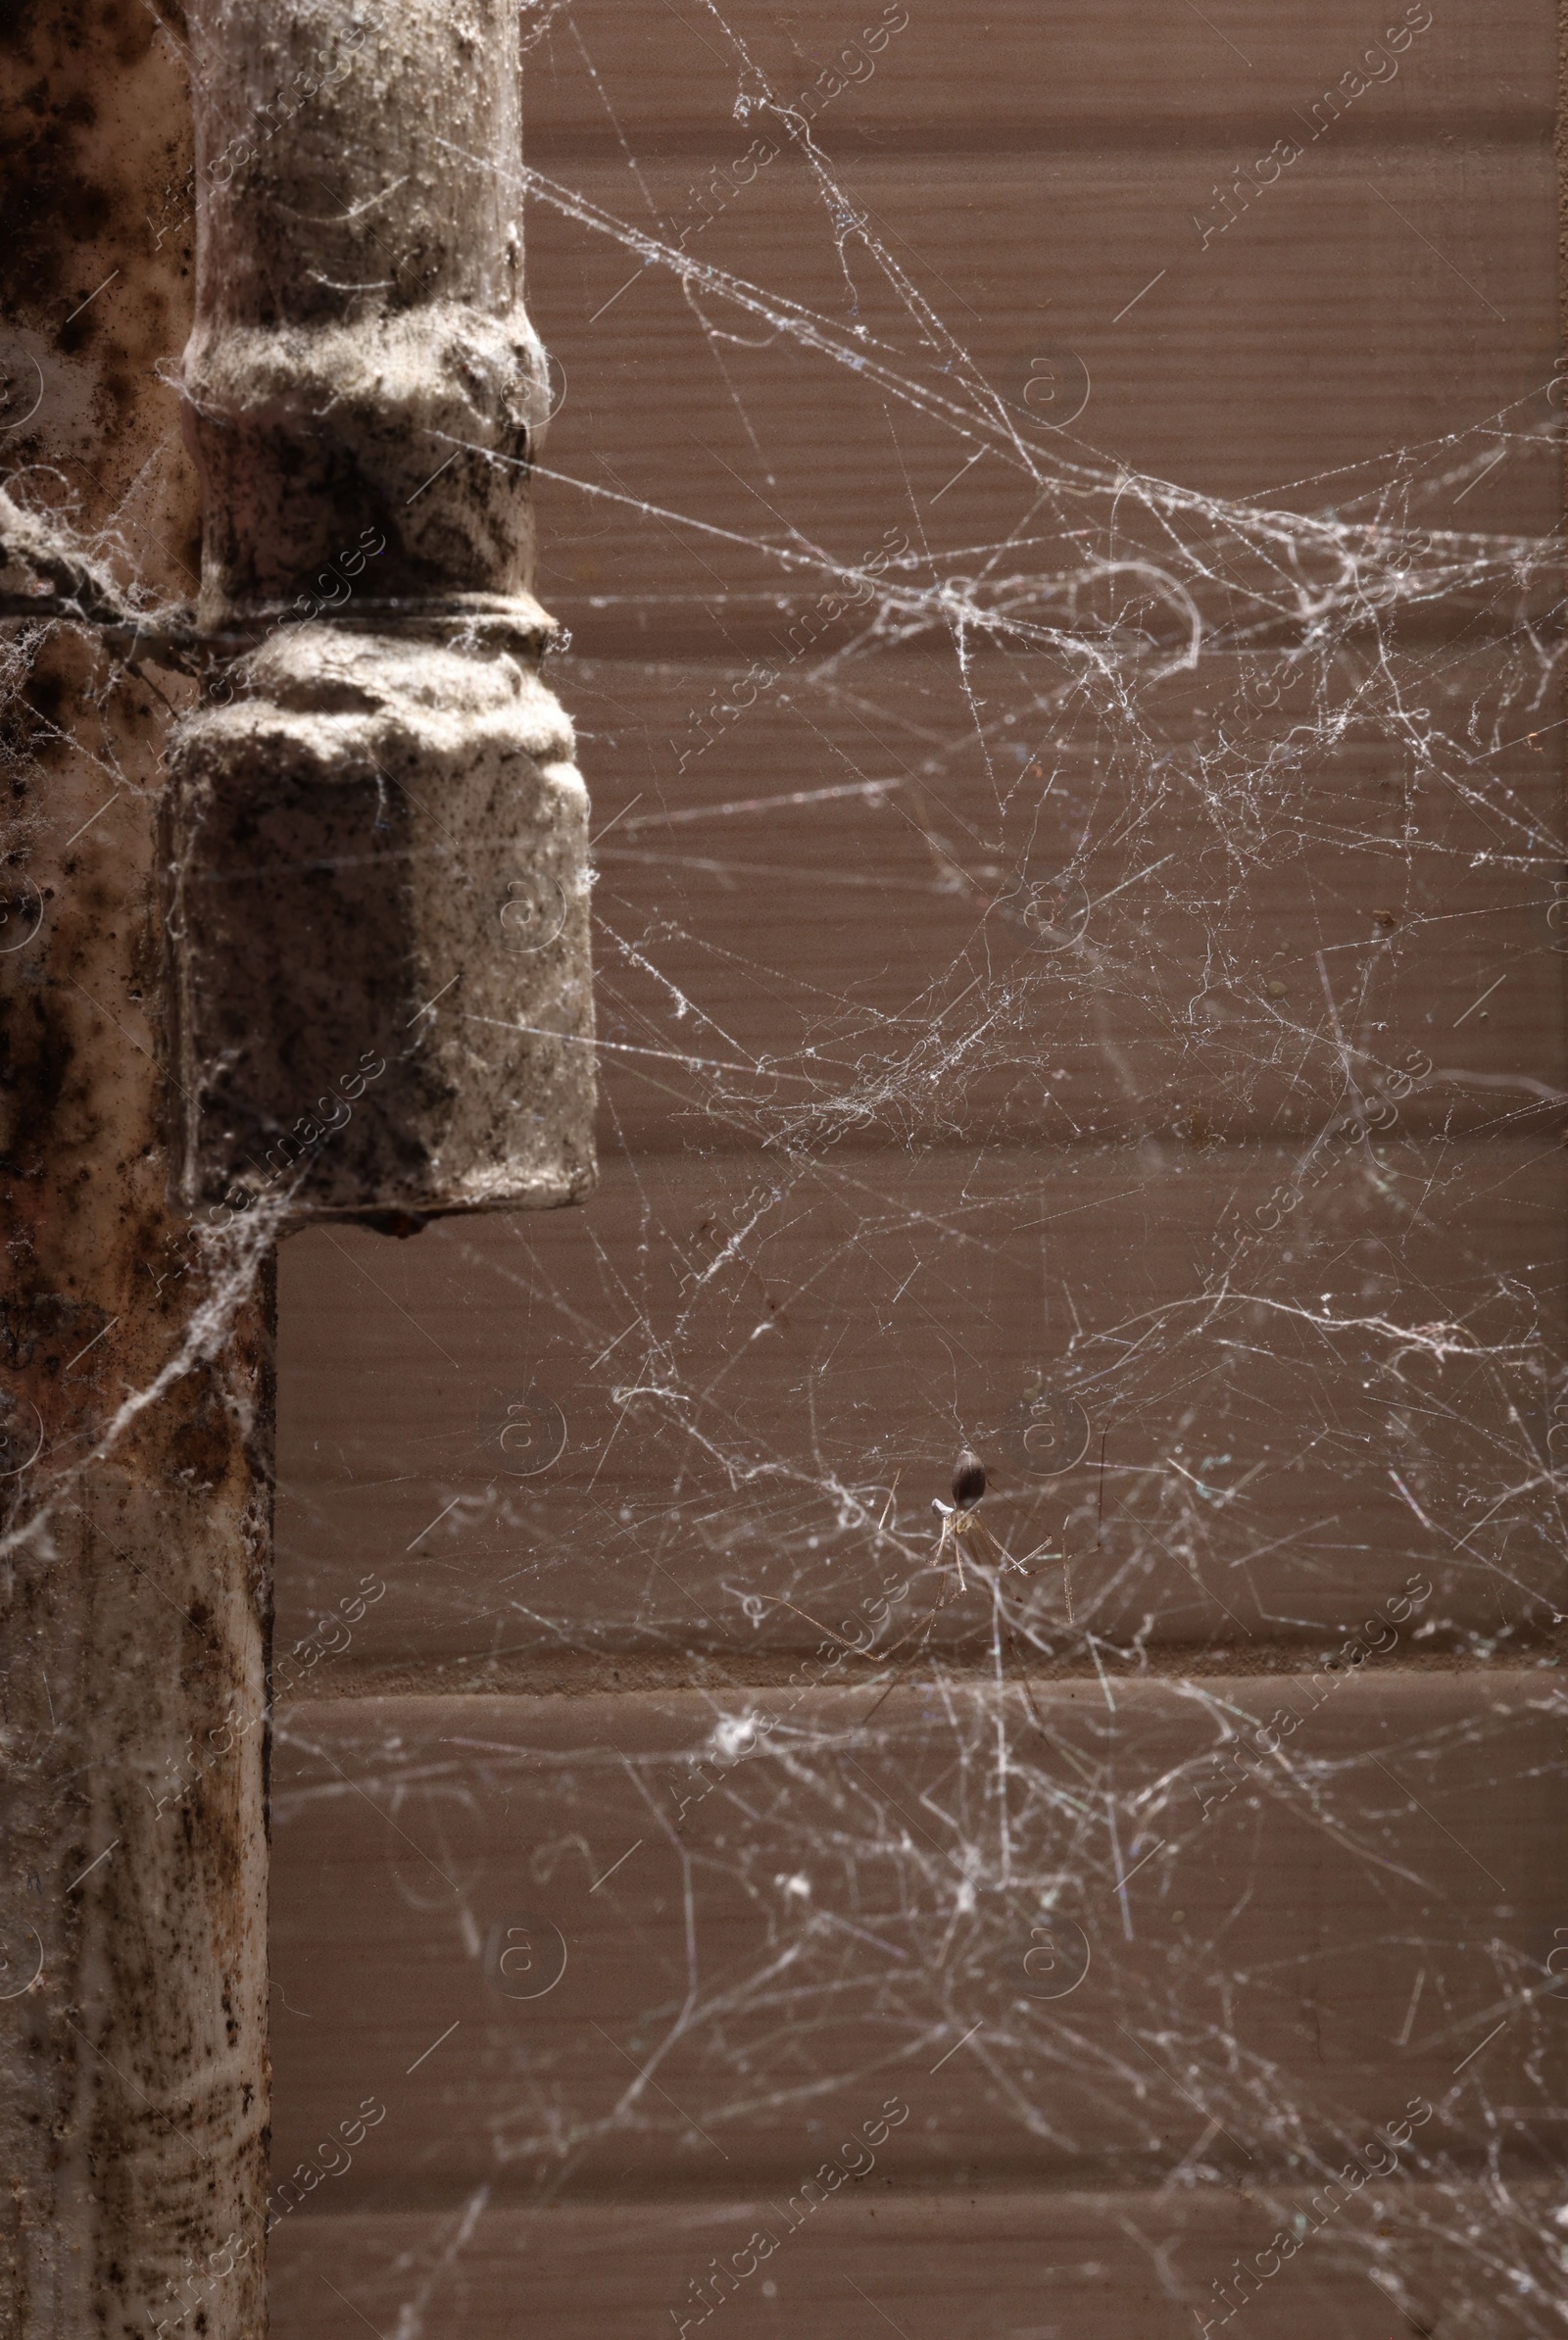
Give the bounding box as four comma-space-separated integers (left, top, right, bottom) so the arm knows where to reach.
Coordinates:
164, 0, 595, 1224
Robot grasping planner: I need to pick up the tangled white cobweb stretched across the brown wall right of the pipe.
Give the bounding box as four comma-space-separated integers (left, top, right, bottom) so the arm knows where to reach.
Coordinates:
6, 0, 1568, 2340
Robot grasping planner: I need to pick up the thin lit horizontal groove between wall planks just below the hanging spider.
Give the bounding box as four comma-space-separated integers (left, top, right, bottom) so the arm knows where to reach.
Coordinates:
275, 1627, 1568, 1708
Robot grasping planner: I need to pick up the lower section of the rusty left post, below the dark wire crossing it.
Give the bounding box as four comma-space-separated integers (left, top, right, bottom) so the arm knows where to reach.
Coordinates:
0, 637, 271, 2340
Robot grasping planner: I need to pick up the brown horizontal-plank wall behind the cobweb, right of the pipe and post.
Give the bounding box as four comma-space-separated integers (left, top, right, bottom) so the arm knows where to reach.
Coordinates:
0, 0, 1568, 2340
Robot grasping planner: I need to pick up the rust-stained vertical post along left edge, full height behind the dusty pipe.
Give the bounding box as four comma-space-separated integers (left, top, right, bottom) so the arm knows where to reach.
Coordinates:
0, 0, 271, 2340
